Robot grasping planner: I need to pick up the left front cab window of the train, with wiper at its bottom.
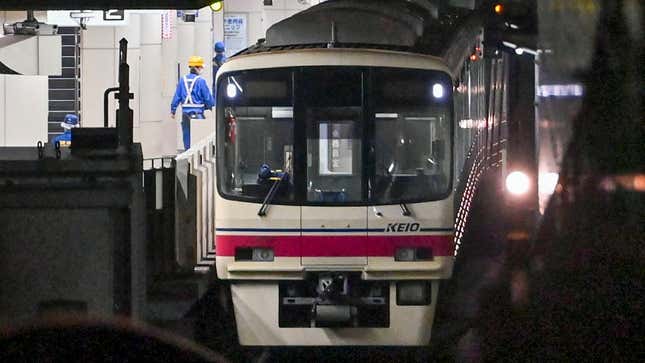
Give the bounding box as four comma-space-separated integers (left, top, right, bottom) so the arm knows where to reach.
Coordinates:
217, 70, 295, 202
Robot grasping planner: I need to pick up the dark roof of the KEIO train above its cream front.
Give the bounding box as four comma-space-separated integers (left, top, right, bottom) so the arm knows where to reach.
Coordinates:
233, 0, 482, 73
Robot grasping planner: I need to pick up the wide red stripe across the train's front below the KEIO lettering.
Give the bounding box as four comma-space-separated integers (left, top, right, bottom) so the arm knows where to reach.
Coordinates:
216, 235, 455, 257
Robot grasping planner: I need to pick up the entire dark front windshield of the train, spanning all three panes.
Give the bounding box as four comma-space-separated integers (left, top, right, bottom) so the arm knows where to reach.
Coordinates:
217, 67, 452, 205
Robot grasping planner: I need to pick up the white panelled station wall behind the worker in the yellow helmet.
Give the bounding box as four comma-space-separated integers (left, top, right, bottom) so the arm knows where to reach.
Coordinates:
71, 0, 319, 158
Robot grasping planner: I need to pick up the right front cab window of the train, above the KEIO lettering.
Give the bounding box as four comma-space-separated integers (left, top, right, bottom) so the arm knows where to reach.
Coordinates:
369, 69, 452, 204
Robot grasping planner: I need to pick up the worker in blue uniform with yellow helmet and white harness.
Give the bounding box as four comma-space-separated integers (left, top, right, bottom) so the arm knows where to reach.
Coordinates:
170, 56, 215, 150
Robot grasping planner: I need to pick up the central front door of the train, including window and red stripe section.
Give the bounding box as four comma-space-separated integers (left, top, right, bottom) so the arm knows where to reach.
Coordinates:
300, 67, 367, 266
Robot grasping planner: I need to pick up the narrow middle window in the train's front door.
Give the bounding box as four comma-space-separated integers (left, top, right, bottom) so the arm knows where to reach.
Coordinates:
300, 68, 363, 204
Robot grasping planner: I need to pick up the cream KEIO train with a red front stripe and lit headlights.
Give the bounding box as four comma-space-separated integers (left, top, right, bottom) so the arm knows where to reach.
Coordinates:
209, 0, 507, 346
